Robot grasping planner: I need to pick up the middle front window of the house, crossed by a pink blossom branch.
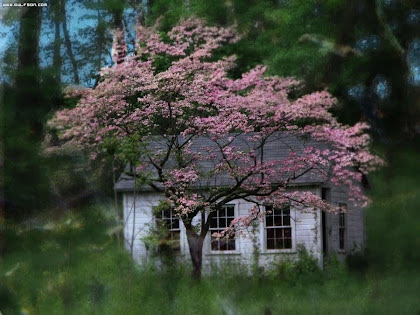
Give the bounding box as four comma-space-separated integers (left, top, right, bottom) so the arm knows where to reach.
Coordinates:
210, 205, 236, 251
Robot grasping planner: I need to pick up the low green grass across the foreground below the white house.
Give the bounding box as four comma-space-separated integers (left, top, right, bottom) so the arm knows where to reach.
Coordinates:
0, 207, 420, 315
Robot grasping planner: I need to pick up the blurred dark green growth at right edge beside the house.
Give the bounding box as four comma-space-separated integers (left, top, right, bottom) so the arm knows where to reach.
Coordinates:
366, 147, 420, 270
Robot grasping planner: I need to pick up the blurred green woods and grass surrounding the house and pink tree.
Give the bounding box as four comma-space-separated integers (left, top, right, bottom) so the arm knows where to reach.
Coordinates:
0, 0, 420, 314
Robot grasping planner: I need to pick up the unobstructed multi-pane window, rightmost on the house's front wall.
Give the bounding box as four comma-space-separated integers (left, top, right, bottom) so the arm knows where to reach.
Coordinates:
265, 205, 292, 249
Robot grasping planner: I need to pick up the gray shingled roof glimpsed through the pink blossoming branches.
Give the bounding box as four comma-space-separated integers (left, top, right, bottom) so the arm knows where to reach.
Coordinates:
115, 132, 327, 192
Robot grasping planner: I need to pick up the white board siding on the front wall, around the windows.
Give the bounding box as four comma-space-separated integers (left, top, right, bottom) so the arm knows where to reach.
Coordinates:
123, 188, 323, 270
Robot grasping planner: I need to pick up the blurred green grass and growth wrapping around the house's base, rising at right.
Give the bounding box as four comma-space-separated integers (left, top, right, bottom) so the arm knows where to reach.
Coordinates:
0, 148, 420, 315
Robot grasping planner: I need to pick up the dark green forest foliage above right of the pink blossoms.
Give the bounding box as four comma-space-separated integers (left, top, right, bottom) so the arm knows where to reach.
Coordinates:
148, 0, 420, 142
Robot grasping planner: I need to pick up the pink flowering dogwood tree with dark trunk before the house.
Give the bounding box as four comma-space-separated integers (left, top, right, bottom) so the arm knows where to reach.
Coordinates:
49, 19, 382, 277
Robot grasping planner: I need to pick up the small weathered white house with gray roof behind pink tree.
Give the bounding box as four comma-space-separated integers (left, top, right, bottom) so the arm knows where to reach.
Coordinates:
116, 135, 365, 269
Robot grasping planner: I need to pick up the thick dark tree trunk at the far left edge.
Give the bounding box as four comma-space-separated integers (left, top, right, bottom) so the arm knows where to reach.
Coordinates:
4, 4, 46, 216
